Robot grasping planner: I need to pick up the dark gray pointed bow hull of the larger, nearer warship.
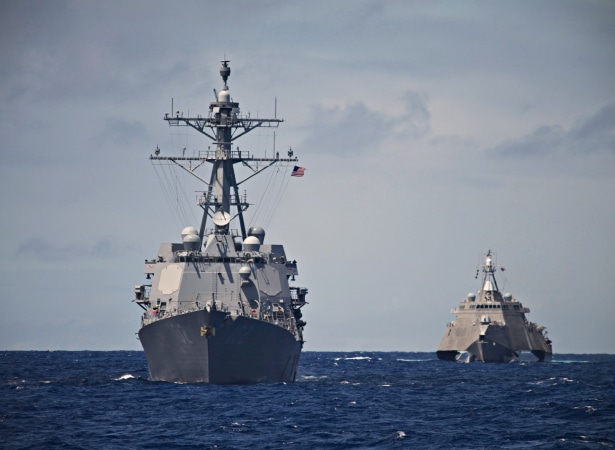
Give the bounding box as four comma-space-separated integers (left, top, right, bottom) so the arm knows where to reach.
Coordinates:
139, 310, 302, 384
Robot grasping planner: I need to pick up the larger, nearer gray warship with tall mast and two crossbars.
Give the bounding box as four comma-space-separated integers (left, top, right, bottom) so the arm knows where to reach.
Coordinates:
133, 60, 307, 384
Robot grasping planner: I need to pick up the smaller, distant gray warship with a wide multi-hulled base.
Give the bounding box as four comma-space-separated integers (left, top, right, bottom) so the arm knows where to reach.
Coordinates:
436, 251, 553, 362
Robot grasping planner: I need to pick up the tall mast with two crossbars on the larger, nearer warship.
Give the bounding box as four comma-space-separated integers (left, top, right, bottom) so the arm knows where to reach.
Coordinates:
150, 59, 298, 245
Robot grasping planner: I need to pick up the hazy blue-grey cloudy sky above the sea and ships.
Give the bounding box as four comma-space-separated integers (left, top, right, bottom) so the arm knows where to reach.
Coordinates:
0, 0, 615, 353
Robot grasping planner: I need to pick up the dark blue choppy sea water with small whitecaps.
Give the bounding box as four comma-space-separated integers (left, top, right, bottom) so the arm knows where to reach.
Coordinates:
0, 351, 615, 450
